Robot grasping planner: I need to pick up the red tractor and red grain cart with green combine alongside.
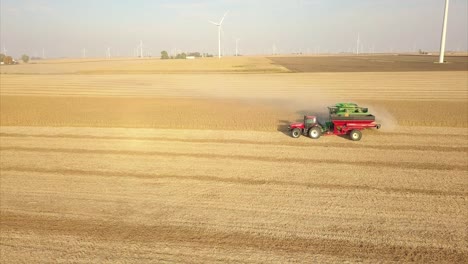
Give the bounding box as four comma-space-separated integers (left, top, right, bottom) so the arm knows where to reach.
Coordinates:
289, 103, 380, 141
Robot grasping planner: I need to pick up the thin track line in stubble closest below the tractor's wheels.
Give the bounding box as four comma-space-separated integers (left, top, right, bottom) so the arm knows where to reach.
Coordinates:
0, 133, 468, 153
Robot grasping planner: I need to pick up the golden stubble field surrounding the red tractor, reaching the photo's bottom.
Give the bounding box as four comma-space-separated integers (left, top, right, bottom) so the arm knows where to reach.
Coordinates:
0, 57, 468, 263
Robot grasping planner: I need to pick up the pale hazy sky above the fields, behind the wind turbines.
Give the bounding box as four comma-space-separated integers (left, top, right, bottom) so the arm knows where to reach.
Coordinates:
0, 0, 468, 57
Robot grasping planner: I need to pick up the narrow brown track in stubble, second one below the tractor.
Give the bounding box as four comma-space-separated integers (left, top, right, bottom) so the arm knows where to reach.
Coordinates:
0, 146, 468, 171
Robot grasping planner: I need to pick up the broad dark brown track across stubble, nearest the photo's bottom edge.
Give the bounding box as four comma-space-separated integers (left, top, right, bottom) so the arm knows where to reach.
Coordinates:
0, 210, 468, 263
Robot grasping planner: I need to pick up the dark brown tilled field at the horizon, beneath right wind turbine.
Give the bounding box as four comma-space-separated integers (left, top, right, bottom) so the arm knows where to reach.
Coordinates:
269, 55, 468, 72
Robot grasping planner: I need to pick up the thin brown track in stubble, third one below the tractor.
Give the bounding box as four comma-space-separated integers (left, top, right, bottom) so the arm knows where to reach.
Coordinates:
1, 166, 468, 197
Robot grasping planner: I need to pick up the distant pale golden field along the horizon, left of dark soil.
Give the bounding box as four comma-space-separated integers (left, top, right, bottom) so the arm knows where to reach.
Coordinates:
0, 57, 289, 75
